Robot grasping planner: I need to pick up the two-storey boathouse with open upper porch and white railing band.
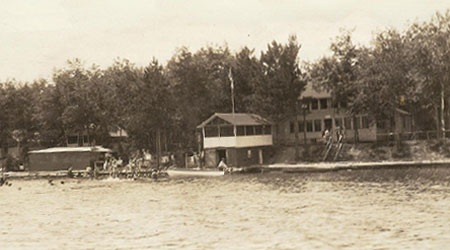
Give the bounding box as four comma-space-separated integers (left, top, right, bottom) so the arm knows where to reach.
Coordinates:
197, 113, 273, 167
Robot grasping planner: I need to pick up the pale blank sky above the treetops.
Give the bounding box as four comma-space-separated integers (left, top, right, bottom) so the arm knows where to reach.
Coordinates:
0, 0, 450, 82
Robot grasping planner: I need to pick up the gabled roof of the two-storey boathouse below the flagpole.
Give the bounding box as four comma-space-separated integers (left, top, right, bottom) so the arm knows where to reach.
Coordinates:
197, 113, 271, 128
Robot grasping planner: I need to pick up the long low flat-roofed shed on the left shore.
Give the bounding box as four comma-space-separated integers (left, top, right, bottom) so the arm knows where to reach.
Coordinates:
28, 146, 112, 171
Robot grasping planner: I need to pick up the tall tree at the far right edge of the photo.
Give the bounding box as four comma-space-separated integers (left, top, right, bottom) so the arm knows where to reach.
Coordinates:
406, 10, 450, 135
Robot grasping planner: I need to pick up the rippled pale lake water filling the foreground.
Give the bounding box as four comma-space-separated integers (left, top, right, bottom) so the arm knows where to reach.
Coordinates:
0, 168, 450, 249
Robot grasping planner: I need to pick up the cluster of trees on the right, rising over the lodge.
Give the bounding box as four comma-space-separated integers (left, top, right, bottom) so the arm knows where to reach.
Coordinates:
307, 11, 450, 136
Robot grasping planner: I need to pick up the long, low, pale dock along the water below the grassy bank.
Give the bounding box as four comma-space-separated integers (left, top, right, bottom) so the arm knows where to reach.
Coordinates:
260, 159, 450, 173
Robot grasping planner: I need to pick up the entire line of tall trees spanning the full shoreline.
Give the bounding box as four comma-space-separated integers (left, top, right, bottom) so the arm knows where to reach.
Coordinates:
0, 11, 450, 164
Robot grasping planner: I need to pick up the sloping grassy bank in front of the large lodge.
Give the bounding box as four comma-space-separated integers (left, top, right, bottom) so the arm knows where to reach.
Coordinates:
270, 140, 450, 163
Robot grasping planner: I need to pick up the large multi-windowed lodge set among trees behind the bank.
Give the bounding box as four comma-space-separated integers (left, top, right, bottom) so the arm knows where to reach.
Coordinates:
276, 84, 413, 144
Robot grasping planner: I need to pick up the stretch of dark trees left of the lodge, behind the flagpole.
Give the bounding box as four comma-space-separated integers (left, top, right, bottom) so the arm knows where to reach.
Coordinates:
0, 36, 304, 162
